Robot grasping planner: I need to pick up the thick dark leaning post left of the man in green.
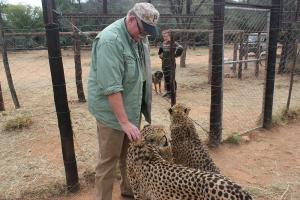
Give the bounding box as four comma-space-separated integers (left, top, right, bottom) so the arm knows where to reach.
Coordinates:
42, 0, 79, 192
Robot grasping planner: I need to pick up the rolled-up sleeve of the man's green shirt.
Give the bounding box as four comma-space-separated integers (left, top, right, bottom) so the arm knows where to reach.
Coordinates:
95, 41, 124, 95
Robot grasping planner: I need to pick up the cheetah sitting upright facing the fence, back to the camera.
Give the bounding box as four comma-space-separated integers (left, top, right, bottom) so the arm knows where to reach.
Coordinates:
169, 104, 220, 173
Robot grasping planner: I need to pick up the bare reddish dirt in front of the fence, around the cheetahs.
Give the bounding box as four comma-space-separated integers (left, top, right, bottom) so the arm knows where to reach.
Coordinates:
56, 121, 300, 200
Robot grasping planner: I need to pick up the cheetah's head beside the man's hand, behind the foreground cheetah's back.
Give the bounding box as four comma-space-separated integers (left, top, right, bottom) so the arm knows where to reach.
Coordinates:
141, 125, 173, 162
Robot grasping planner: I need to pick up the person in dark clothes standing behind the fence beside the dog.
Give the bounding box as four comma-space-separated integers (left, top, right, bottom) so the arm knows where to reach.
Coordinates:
158, 30, 183, 98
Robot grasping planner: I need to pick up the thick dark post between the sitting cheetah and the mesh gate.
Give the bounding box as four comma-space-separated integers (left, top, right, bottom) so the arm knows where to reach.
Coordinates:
209, 0, 225, 147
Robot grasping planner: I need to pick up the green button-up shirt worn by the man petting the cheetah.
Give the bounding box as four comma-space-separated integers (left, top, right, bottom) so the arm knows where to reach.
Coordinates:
88, 18, 151, 130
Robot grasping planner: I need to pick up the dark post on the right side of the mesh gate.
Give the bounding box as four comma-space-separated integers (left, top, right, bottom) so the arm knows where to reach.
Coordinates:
263, 0, 280, 129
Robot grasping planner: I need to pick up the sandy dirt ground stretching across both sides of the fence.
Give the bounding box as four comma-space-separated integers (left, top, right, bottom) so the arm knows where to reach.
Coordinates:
0, 47, 300, 199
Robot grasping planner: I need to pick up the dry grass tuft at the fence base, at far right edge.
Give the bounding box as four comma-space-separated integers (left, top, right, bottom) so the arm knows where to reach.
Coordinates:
272, 108, 300, 126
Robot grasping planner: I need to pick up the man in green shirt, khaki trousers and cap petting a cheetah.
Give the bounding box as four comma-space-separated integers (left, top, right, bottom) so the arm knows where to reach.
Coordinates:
88, 3, 159, 200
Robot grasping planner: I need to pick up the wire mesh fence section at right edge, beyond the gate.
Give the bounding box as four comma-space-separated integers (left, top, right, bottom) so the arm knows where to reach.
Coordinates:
273, 1, 300, 119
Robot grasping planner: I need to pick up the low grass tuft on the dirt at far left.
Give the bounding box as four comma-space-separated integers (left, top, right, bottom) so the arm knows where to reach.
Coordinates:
4, 115, 33, 131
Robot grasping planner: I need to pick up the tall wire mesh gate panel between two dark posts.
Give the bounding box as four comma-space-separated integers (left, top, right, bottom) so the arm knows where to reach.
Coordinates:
223, 6, 270, 134
